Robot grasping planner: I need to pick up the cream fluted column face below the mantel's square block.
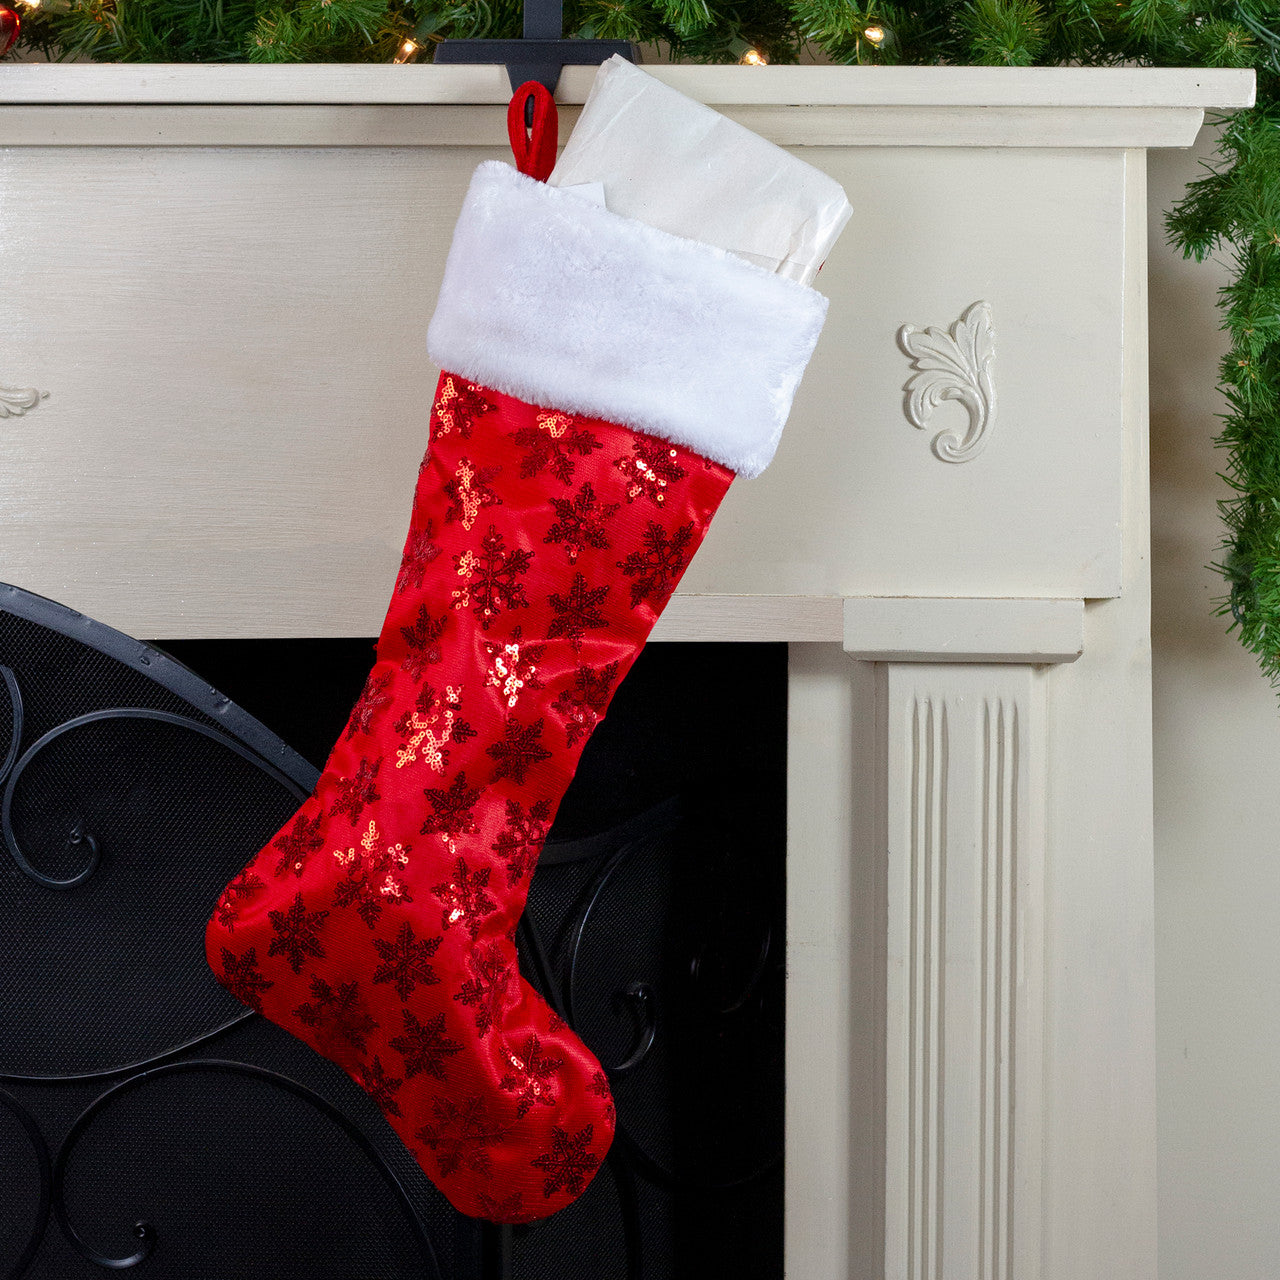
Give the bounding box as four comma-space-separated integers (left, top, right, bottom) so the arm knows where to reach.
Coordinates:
879, 663, 1046, 1280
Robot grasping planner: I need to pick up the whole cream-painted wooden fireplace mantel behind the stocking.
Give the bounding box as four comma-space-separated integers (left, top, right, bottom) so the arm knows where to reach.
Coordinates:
0, 64, 1253, 1280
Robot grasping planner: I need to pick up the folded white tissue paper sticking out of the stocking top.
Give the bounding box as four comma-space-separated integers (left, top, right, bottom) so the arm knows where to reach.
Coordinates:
548, 54, 852, 284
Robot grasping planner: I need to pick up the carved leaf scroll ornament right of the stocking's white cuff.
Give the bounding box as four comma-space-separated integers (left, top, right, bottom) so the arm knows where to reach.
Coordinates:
897, 302, 996, 462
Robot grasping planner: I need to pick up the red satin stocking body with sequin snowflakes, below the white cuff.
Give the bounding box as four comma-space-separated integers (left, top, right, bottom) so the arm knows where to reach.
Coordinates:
207, 374, 732, 1222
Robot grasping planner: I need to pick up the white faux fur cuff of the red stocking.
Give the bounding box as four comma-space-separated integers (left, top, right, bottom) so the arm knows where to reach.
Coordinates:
428, 160, 827, 476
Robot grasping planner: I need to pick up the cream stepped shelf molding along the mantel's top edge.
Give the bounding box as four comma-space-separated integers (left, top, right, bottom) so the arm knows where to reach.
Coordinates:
0, 63, 1253, 148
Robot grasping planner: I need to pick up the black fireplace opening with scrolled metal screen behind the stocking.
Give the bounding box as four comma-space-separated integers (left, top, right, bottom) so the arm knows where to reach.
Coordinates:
0, 588, 786, 1280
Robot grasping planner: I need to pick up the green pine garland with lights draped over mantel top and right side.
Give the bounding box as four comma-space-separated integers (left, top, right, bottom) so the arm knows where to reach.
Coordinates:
8, 0, 1280, 685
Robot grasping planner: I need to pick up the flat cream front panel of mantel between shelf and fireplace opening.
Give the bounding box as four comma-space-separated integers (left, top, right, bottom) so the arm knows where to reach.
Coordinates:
0, 146, 1141, 639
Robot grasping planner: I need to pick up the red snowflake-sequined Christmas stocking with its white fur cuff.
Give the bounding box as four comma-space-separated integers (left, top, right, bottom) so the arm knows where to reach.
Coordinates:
207, 99, 826, 1221
